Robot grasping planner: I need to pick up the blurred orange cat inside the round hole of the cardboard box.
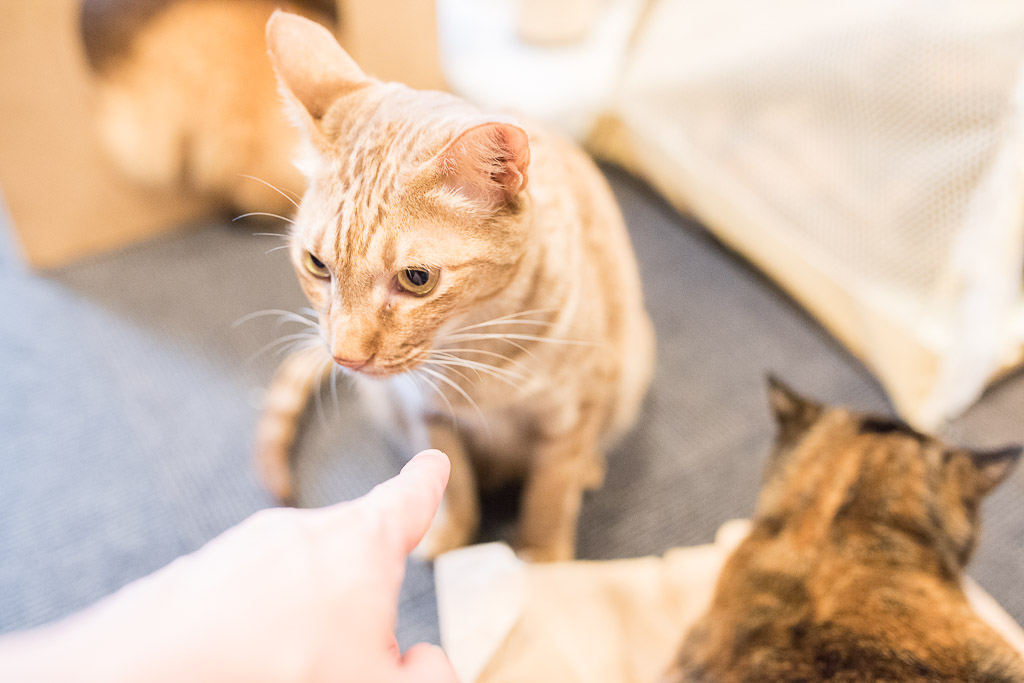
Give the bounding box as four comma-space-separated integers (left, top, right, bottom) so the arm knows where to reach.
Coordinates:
81, 0, 335, 213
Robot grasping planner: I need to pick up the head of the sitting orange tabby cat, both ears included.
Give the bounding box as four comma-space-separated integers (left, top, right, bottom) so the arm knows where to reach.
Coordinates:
267, 11, 529, 376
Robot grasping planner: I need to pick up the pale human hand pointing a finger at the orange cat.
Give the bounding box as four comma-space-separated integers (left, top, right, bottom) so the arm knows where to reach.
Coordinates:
0, 451, 456, 683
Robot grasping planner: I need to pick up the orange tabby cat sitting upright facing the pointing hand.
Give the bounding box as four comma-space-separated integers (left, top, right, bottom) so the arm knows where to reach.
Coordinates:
259, 12, 653, 560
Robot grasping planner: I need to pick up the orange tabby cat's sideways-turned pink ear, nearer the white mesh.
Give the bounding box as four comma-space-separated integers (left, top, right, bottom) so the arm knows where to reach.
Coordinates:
438, 121, 529, 207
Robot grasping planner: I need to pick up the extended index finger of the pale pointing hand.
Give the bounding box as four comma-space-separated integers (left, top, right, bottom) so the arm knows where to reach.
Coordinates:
364, 450, 452, 555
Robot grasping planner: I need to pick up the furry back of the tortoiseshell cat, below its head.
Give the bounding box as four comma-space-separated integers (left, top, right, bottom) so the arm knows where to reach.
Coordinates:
666, 537, 1024, 683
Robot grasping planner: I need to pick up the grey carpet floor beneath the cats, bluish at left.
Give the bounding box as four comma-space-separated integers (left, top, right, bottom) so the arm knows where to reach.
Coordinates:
0, 163, 1024, 645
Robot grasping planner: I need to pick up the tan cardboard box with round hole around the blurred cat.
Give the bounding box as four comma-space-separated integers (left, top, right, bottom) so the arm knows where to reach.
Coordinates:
0, 0, 443, 267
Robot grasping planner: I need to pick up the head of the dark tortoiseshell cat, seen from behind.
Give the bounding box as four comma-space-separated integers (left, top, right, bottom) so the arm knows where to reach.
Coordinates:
757, 379, 1021, 573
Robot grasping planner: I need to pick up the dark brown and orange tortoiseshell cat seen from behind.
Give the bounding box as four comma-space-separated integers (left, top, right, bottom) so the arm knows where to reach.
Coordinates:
665, 380, 1024, 683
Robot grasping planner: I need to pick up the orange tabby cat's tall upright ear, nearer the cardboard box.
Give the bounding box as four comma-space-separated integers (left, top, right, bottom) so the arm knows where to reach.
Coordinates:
266, 9, 370, 124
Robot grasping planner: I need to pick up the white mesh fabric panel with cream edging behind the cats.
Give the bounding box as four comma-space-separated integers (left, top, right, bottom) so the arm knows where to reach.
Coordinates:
594, 0, 1024, 428
